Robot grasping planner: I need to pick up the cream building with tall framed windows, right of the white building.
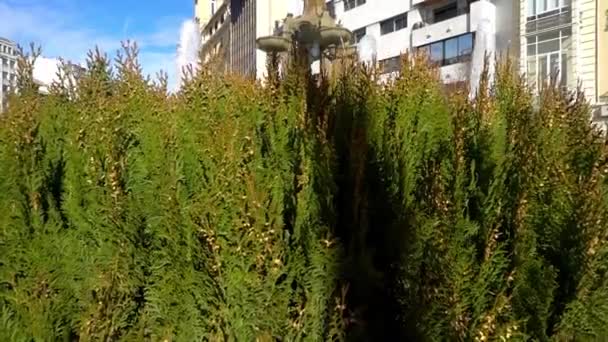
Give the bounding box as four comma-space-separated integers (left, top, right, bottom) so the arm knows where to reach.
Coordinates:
520, 0, 608, 124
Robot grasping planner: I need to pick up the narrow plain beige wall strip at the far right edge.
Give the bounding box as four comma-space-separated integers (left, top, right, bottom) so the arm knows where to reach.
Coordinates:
597, 0, 608, 104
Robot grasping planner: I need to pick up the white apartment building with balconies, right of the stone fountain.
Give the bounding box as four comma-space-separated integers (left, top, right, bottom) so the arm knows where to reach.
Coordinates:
292, 0, 519, 83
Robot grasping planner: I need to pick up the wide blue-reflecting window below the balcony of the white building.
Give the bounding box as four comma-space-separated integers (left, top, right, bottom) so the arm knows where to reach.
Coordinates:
417, 33, 473, 65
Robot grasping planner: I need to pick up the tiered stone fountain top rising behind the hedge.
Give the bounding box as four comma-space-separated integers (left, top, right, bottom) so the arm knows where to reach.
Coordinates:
256, 0, 354, 63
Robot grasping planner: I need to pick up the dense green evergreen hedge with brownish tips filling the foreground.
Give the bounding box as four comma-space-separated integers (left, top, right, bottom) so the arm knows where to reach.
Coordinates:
0, 44, 608, 341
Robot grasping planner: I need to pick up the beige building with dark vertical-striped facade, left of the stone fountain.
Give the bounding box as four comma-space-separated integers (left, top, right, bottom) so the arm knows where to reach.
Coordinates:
195, 0, 288, 78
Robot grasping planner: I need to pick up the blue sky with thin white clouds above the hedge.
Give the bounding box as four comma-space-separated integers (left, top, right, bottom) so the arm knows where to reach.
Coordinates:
0, 0, 194, 89
